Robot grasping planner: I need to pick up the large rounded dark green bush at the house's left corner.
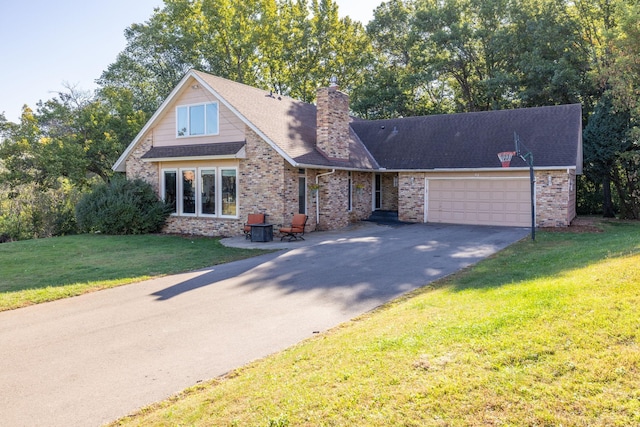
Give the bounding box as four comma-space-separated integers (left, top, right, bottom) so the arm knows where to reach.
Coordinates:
76, 178, 170, 234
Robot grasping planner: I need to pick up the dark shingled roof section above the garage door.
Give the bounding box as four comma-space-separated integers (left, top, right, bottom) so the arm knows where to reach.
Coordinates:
351, 104, 582, 172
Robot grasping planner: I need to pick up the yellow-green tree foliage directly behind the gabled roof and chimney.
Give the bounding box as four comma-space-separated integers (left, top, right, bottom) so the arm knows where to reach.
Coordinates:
99, 0, 371, 108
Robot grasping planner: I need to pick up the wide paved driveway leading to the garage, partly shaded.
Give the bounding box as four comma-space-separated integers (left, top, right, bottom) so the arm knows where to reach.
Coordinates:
0, 223, 528, 426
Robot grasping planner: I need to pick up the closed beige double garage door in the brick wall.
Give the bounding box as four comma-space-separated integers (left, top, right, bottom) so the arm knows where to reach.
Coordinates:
425, 177, 531, 227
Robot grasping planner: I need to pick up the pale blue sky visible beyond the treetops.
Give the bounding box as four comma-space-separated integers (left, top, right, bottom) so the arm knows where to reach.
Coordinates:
0, 0, 383, 122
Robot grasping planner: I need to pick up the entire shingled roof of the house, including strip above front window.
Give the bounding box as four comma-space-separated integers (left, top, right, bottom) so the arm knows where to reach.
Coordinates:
113, 70, 582, 173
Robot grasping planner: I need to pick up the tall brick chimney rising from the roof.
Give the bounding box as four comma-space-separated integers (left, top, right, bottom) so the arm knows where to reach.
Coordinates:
316, 84, 350, 160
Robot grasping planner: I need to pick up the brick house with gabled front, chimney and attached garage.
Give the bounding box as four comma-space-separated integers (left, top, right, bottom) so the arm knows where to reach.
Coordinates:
113, 70, 582, 236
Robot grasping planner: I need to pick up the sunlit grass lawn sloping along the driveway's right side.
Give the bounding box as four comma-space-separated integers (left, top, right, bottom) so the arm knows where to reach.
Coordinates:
115, 224, 640, 427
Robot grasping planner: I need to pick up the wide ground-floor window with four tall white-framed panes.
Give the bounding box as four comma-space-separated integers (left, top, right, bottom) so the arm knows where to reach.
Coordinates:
162, 167, 238, 218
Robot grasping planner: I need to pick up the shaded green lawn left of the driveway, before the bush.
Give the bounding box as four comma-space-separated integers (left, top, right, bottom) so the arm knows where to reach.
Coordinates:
0, 234, 266, 311
